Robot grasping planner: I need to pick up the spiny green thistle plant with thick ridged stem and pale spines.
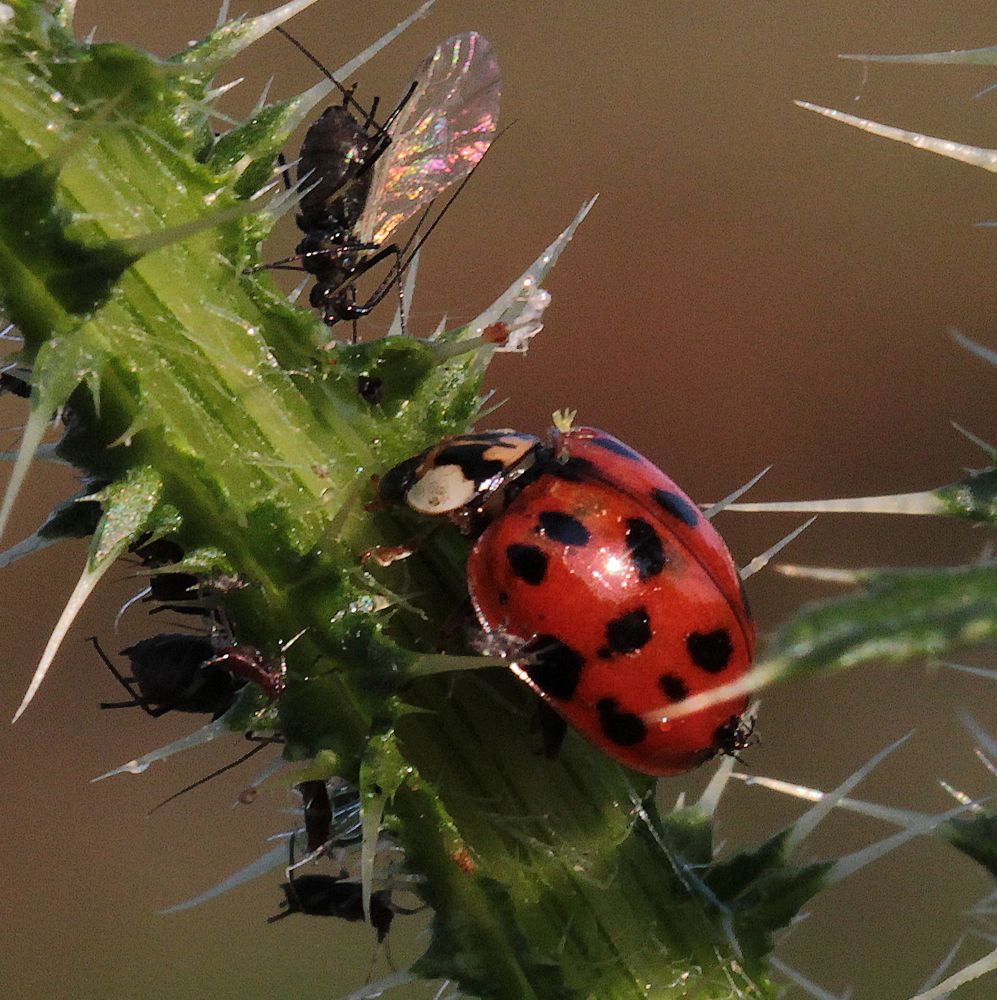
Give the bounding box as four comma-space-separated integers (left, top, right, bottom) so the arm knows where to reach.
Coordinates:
0, 0, 997, 1000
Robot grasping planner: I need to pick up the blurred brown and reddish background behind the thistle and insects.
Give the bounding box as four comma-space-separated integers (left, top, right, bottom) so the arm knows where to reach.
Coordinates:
0, 0, 997, 1000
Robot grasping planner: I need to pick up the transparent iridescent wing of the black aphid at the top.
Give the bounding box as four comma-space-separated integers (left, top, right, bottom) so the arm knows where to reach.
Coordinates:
356, 31, 499, 245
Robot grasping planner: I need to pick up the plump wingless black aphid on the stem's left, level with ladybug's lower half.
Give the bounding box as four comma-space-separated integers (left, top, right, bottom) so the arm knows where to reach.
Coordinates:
91, 632, 284, 719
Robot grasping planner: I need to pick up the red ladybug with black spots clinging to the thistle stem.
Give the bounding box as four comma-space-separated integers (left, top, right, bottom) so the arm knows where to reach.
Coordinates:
379, 427, 755, 775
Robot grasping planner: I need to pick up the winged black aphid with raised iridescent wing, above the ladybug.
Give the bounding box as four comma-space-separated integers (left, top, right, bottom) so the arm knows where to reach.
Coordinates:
249, 29, 499, 339
